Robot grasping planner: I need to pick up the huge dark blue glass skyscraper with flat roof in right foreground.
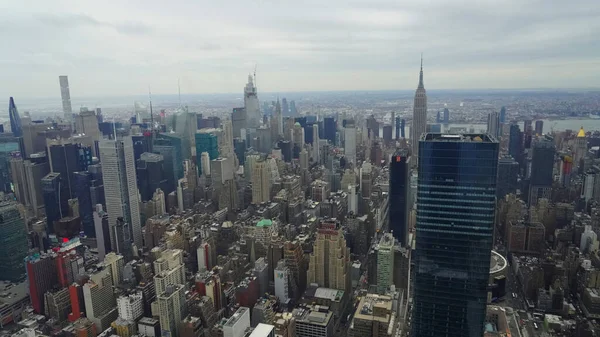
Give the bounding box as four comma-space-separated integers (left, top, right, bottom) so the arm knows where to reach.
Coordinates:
412, 134, 498, 337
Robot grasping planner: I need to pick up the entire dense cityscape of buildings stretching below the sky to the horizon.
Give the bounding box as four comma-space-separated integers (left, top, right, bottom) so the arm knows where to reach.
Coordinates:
0, 59, 600, 337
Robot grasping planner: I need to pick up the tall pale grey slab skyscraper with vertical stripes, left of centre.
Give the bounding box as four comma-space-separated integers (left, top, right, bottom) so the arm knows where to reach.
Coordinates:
99, 137, 142, 248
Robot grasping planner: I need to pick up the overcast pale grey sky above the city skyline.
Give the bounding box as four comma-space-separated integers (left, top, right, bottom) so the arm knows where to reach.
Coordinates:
0, 0, 600, 97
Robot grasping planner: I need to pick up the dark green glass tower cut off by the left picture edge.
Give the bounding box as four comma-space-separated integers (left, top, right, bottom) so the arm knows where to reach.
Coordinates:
0, 201, 28, 282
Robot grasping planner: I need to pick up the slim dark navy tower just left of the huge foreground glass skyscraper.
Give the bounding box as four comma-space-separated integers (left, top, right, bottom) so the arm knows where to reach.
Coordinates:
389, 149, 410, 246
